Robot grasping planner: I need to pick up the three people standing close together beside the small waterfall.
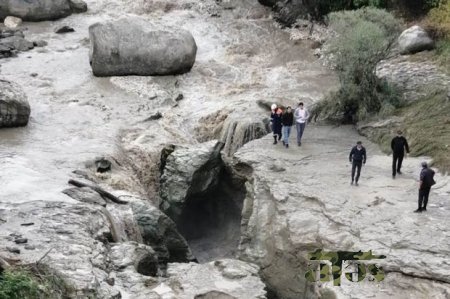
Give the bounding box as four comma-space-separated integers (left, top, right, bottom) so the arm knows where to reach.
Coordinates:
270, 102, 309, 148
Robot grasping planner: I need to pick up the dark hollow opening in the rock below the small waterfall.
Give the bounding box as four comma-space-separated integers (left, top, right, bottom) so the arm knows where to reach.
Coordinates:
176, 167, 246, 262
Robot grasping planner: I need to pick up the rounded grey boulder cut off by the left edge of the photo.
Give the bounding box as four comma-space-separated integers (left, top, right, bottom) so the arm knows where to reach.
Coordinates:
0, 80, 30, 128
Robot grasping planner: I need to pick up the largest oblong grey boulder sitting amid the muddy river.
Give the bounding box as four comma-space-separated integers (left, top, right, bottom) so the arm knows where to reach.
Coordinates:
89, 18, 197, 76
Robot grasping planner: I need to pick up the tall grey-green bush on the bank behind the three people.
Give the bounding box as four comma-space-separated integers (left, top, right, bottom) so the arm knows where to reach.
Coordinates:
313, 8, 401, 122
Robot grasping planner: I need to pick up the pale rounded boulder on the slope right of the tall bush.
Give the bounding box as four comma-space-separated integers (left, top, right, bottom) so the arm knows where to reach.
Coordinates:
398, 25, 434, 54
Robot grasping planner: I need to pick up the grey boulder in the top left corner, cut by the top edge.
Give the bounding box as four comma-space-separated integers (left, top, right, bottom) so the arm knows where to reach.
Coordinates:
0, 0, 77, 21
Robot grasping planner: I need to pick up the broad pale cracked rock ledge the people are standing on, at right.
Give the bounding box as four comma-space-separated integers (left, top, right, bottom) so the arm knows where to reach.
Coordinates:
234, 125, 450, 299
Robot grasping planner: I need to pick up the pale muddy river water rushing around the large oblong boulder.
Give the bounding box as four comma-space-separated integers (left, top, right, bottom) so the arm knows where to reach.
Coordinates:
0, 0, 335, 209
